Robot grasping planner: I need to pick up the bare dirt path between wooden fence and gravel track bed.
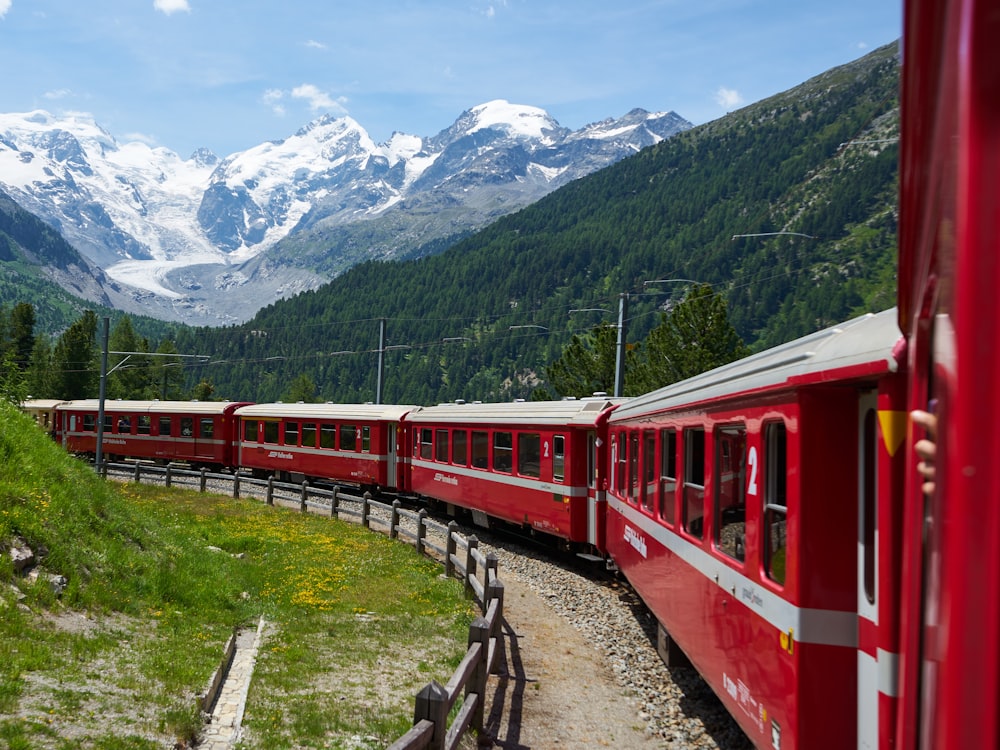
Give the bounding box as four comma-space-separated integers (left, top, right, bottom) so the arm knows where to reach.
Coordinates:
479, 575, 659, 750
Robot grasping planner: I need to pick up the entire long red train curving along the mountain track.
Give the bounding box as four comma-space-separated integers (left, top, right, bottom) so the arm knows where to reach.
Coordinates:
21, 0, 1000, 750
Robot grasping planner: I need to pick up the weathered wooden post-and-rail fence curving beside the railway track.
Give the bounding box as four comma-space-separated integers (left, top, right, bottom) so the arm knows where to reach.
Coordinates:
100, 462, 504, 750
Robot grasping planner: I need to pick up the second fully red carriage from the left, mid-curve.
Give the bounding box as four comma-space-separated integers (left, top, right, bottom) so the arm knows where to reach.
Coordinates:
236, 403, 420, 490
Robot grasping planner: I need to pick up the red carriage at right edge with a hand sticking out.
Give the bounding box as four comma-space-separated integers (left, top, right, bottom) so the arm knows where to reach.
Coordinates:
897, 0, 1000, 748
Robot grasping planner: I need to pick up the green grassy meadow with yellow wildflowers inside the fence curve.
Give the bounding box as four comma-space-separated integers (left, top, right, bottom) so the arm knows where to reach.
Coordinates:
0, 405, 474, 750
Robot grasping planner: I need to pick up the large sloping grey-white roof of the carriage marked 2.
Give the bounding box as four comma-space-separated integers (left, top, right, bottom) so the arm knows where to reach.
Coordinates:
612, 308, 902, 421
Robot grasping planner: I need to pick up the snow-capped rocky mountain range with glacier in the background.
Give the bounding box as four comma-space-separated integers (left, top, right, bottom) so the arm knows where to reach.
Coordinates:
0, 100, 691, 323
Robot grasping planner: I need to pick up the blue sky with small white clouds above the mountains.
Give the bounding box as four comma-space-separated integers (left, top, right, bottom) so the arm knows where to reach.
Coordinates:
0, 0, 902, 157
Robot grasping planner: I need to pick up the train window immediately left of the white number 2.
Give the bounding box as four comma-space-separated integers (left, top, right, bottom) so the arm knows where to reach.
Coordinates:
714, 425, 747, 561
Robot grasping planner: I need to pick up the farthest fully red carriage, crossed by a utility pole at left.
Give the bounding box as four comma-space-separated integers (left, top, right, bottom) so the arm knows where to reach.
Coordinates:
56, 399, 246, 469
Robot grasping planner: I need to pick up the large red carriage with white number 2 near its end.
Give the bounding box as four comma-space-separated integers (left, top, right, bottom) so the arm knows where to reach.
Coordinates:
607, 310, 906, 750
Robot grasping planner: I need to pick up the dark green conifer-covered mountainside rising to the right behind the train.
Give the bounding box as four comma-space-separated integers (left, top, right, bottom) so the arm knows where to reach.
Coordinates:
168, 43, 899, 404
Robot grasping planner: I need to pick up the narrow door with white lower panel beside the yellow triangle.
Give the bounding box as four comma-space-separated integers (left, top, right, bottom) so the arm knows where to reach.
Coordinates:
857, 391, 880, 750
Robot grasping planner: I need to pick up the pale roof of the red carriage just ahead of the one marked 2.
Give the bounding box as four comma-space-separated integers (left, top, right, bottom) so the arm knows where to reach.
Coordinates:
408, 398, 626, 426
